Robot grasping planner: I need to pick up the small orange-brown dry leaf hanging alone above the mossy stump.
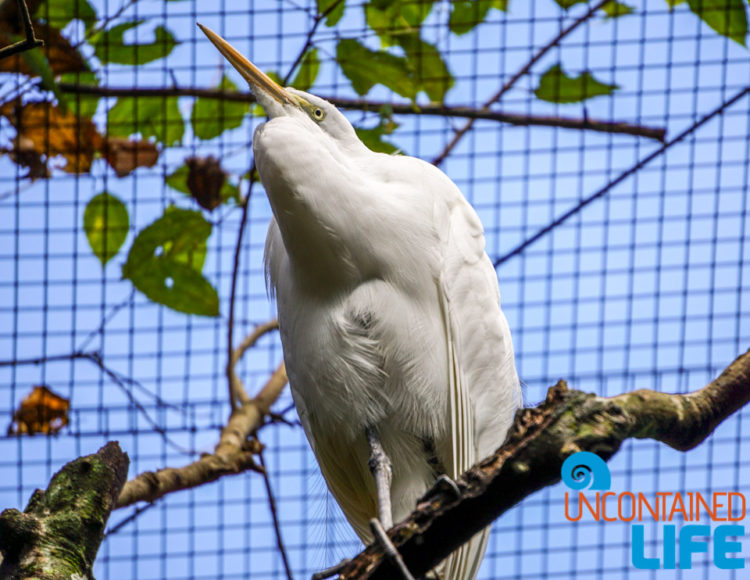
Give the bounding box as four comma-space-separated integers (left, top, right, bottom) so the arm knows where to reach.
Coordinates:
8, 385, 70, 435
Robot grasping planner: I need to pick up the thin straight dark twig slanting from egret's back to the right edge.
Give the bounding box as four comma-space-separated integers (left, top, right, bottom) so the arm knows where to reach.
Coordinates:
494, 87, 750, 268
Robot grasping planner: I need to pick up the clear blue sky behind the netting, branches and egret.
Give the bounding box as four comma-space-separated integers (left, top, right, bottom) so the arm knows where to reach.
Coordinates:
0, 0, 750, 579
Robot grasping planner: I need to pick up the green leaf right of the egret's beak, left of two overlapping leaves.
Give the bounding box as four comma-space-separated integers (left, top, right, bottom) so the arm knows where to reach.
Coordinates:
336, 38, 418, 100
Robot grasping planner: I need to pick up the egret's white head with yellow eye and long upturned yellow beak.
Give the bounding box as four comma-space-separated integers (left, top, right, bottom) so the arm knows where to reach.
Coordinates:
198, 24, 359, 141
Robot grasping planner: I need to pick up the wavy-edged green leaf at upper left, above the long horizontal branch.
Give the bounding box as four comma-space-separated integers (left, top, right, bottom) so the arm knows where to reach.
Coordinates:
89, 20, 177, 65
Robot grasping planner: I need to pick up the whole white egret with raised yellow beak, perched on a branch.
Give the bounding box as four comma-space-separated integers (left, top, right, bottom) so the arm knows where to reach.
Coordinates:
199, 25, 521, 580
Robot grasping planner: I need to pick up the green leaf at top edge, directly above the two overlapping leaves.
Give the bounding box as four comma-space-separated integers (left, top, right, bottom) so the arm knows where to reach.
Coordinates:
365, 0, 435, 46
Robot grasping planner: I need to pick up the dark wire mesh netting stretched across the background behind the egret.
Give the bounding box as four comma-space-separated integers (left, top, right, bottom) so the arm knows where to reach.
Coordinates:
0, 0, 750, 580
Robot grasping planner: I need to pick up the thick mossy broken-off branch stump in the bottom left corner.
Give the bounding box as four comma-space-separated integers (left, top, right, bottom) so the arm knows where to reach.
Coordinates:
0, 442, 130, 580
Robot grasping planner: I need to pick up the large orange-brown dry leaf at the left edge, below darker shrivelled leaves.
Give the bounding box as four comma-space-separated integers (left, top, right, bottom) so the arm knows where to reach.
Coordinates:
0, 101, 102, 173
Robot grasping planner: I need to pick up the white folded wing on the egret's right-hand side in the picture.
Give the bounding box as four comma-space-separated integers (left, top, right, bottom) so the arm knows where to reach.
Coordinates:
436, 172, 521, 580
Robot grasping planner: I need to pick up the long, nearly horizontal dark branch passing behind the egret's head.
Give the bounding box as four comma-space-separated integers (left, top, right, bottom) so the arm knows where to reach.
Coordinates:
58, 83, 667, 141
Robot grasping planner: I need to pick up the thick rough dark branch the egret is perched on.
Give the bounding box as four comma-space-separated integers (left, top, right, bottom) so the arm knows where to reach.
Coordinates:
339, 351, 750, 579
